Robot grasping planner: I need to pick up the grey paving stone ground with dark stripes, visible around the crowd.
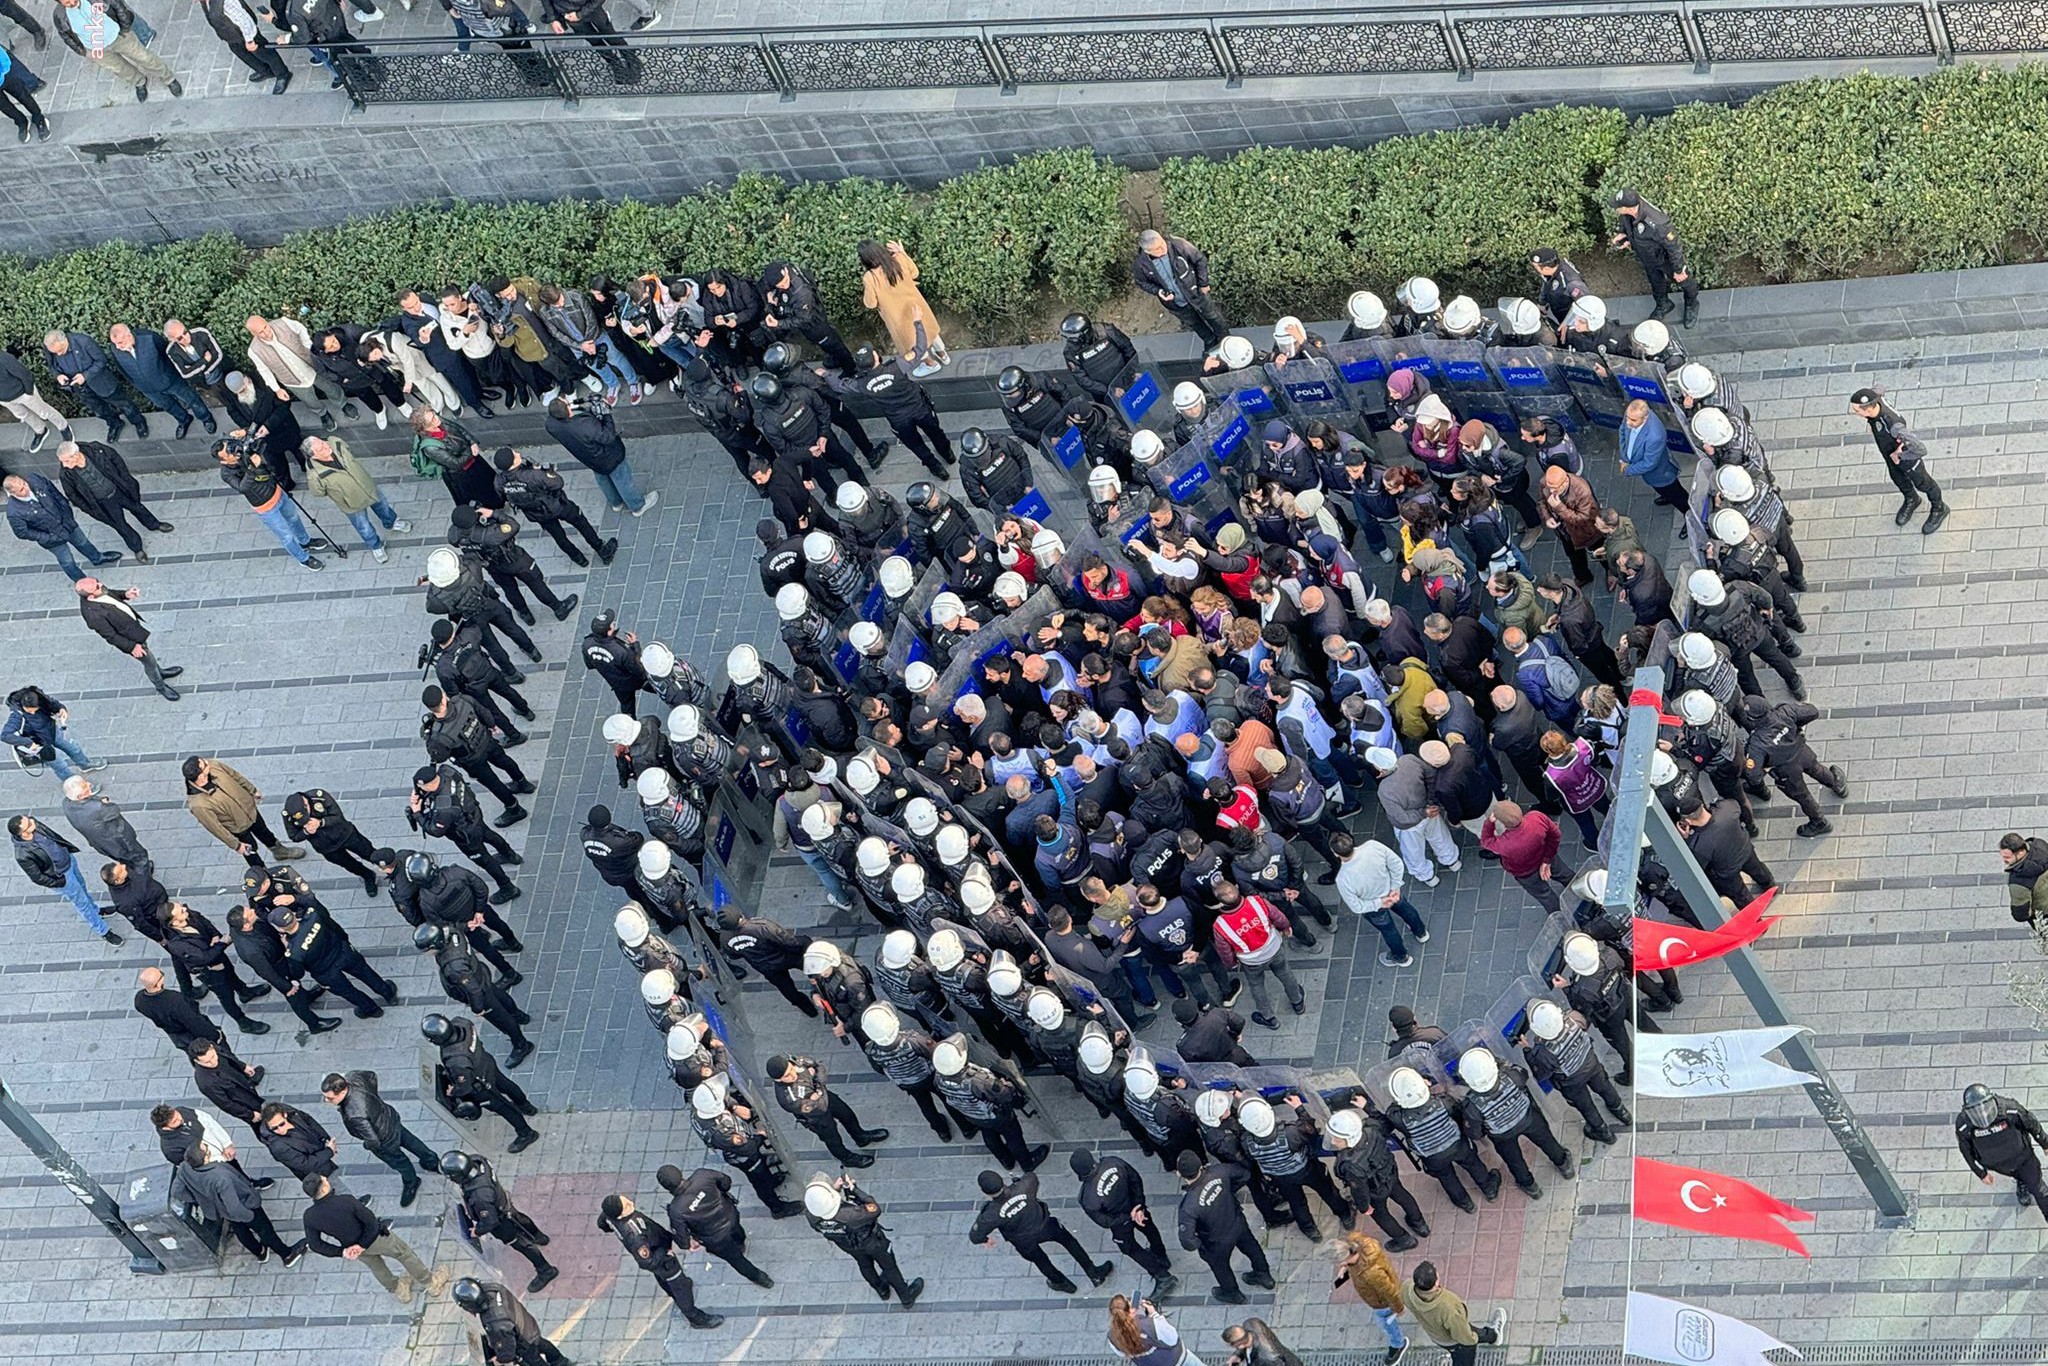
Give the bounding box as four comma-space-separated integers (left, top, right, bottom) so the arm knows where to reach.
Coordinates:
0, 325, 2048, 1366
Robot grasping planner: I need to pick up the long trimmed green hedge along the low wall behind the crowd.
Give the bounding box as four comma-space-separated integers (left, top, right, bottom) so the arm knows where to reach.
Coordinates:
12, 66, 2048, 417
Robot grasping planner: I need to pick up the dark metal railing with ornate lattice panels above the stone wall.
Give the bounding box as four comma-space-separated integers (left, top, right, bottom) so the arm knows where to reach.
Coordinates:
319, 0, 2048, 106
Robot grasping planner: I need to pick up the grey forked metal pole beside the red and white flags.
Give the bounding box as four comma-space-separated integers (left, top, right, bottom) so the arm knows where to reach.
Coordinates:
1606, 668, 1913, 1229
